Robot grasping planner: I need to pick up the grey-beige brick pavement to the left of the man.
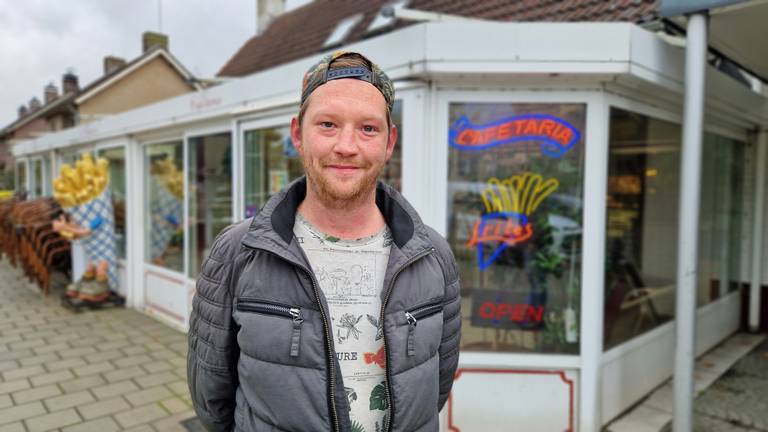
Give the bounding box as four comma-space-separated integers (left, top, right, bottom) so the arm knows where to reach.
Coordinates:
0, 259, 194, 432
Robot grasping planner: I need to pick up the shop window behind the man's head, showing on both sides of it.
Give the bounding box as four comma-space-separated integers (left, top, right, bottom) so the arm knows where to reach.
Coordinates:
244, 100, 403, 218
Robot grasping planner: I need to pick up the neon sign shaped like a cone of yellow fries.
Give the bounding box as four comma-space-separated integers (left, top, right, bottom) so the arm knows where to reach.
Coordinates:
467, 172, 560, 270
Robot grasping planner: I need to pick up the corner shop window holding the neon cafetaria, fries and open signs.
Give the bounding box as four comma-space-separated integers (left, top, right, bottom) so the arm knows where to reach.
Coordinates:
447, 103, 586, 354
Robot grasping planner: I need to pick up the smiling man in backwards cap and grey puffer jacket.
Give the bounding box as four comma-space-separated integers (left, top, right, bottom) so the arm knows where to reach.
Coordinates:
187, 52, 461, 432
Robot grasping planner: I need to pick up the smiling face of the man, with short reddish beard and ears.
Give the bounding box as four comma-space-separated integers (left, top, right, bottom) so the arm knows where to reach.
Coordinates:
291, 79, 397, 207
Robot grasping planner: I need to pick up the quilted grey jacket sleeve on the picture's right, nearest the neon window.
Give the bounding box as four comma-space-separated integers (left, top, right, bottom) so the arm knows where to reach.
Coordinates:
437, 240, 461, 411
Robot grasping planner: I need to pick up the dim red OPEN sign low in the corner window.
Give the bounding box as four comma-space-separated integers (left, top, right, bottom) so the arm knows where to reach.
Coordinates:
471, 290, 545, 329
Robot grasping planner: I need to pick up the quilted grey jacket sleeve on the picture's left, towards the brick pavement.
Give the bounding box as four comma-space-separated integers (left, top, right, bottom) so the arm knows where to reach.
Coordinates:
187, 227, 240, 431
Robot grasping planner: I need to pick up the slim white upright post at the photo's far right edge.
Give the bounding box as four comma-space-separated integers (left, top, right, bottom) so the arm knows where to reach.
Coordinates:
749, 131, 768, 332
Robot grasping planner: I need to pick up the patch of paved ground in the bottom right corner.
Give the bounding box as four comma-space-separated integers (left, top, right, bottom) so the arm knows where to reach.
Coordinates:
694, 339, 768, 432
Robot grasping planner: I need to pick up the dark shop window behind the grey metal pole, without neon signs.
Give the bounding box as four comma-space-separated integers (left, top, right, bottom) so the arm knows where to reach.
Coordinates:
604, 108, 744, 349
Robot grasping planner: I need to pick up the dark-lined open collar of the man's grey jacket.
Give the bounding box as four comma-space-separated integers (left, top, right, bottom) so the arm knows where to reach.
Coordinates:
242, 177, 432, 256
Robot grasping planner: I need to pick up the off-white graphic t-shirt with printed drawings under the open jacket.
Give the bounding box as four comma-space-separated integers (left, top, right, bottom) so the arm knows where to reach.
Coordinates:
293, 214, 392, 432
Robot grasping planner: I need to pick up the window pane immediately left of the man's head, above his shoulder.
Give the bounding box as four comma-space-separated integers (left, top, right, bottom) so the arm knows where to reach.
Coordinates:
244, 126, 304, 218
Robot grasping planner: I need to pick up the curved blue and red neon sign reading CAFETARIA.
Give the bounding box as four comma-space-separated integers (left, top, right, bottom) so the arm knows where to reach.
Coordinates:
448, 114, 581, 158
